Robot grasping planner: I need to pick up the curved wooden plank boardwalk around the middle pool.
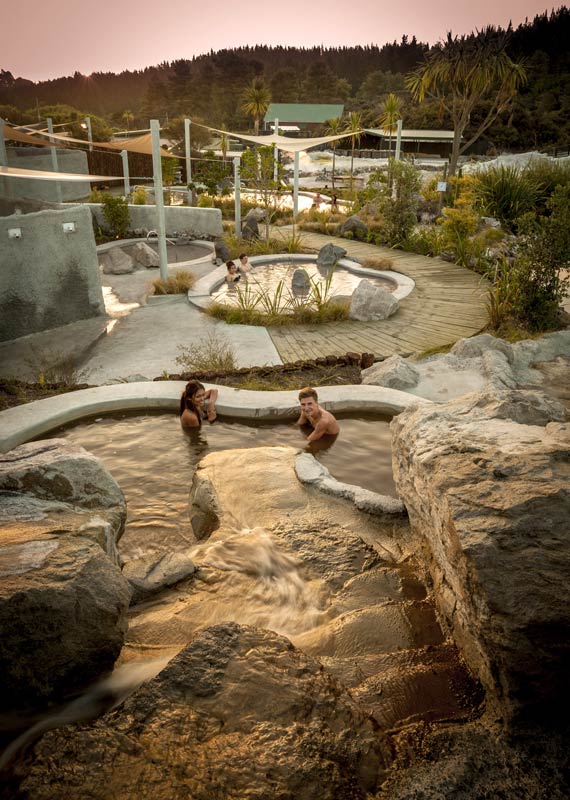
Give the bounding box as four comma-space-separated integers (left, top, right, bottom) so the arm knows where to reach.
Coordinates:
267, 228, 488, 363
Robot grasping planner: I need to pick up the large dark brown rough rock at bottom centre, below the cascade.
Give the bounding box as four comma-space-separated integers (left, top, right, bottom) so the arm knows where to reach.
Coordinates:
21, 623, 388, 800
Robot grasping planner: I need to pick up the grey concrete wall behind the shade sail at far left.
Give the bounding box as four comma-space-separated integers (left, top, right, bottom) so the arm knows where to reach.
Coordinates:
3, 147, 90, 203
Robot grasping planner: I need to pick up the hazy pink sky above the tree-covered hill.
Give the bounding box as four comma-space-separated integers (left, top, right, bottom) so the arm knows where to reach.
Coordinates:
4, 0, 562, 81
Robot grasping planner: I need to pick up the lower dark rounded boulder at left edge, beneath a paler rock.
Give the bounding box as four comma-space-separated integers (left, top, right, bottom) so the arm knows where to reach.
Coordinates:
0, 530, 130, 710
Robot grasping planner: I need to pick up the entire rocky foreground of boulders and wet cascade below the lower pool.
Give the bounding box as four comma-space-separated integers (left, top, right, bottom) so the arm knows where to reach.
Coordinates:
0, 340, 570, 800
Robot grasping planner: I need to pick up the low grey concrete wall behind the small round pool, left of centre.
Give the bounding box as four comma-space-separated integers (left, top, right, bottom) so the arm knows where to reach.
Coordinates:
87, 203, 224, 239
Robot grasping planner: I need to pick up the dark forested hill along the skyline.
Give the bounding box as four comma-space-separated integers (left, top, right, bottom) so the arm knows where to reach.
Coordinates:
0, 7, 570, 148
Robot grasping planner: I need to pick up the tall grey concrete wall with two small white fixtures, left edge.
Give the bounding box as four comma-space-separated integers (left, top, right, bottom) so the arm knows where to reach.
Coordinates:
0, 206, 105, 341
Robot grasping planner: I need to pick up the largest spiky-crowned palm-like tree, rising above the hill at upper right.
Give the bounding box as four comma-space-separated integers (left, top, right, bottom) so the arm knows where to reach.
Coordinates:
406, 26, 526, 175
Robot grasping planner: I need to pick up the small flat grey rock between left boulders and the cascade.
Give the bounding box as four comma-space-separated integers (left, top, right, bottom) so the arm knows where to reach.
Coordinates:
123, 552, 196, 603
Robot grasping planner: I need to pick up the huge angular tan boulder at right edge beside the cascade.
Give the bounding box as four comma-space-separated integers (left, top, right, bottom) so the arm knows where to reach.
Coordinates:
392, 391, 570, 723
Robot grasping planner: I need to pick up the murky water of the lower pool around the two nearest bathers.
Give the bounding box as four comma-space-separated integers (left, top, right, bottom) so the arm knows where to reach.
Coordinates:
52, 414, 396, 558
